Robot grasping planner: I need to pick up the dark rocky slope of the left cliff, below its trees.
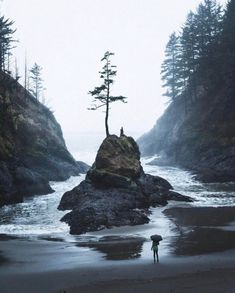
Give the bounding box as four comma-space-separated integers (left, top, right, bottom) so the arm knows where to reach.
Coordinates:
0, 73, 86, 206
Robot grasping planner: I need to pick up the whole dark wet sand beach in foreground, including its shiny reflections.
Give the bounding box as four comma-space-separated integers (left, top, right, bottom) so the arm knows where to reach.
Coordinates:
0, 207, 235, 293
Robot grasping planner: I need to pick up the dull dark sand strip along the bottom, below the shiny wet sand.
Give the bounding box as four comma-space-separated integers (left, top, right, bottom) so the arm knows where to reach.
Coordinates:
0, 252, 235, 293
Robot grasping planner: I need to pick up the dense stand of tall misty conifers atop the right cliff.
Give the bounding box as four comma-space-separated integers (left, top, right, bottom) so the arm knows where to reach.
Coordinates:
161, 0, 227, 103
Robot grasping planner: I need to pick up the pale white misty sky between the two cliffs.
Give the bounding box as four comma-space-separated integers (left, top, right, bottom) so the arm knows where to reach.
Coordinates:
1, 0, 225, 141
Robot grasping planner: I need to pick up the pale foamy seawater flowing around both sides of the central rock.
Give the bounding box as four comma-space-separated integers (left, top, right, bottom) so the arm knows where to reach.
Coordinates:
0, 135, 235, 259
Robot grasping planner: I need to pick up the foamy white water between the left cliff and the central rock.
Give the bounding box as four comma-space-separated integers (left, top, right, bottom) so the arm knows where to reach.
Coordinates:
0, 175, 84, 235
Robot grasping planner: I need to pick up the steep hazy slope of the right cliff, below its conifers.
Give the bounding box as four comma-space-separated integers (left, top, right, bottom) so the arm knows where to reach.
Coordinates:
138, 88, 235, 182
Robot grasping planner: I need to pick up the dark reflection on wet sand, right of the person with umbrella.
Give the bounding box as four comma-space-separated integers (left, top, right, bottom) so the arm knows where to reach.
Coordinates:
164, 207, 235, 255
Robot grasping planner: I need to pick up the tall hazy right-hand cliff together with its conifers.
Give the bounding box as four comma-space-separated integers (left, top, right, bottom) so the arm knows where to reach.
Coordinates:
139, 0, 235, 182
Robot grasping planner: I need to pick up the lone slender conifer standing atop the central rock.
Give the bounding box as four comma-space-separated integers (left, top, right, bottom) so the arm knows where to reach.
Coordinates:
89, 51, 127, 136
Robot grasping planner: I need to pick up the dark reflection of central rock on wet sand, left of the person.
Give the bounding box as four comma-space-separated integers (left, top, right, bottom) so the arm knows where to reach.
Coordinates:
76, 236, 145, 260
